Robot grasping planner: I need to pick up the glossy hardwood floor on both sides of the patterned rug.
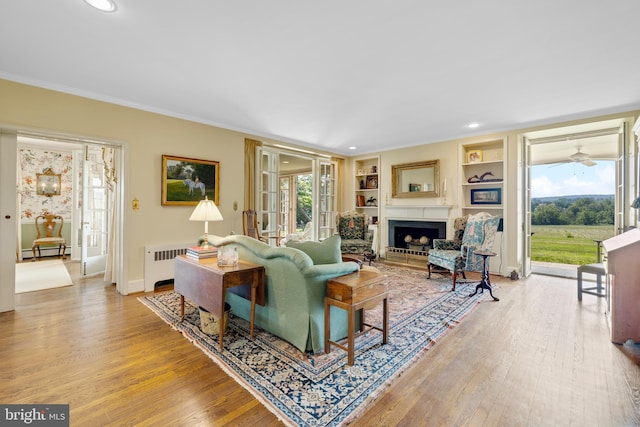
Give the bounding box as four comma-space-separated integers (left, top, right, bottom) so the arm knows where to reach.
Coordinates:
0, 263, 640, 426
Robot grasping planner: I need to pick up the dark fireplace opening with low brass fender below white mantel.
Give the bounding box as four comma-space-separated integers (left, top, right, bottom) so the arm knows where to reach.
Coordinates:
386, 219, 447, 266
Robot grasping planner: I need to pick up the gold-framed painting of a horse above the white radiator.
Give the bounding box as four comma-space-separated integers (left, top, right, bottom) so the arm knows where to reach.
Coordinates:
162, 154, 220, 206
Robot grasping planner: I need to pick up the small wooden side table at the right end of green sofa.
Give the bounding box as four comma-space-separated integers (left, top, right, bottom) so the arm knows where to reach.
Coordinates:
324, 268, 389, 366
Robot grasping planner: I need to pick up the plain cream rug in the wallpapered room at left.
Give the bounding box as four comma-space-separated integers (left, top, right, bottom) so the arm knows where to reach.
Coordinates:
16, 259, 73, 294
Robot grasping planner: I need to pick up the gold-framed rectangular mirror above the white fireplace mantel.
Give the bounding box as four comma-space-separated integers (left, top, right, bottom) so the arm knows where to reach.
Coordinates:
391, 160, 440, 198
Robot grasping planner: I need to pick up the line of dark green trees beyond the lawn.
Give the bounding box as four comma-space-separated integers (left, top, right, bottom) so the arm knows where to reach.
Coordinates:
531, 196, 615, 225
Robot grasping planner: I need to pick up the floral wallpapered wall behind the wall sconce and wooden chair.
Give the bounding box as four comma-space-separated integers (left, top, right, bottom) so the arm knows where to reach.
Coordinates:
18, 148, 73, 223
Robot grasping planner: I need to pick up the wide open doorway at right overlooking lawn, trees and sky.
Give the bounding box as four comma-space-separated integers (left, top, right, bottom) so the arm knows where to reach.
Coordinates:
522, 118, 636, 278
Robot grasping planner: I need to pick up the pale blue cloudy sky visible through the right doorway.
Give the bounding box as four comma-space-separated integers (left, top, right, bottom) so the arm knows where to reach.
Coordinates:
531, 160, 616, 198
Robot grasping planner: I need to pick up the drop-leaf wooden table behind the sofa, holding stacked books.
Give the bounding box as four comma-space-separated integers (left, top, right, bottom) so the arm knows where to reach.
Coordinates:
173, 255, 265, 351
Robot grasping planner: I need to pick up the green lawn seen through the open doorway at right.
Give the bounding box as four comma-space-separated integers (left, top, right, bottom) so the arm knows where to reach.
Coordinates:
531, 225, 615, 265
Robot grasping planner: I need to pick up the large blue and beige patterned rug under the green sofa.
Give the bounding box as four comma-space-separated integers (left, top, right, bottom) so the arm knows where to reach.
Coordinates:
139, 265, 496, 426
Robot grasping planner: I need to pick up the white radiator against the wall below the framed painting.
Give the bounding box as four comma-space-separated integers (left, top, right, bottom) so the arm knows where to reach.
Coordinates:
144, 242, 193, 292
